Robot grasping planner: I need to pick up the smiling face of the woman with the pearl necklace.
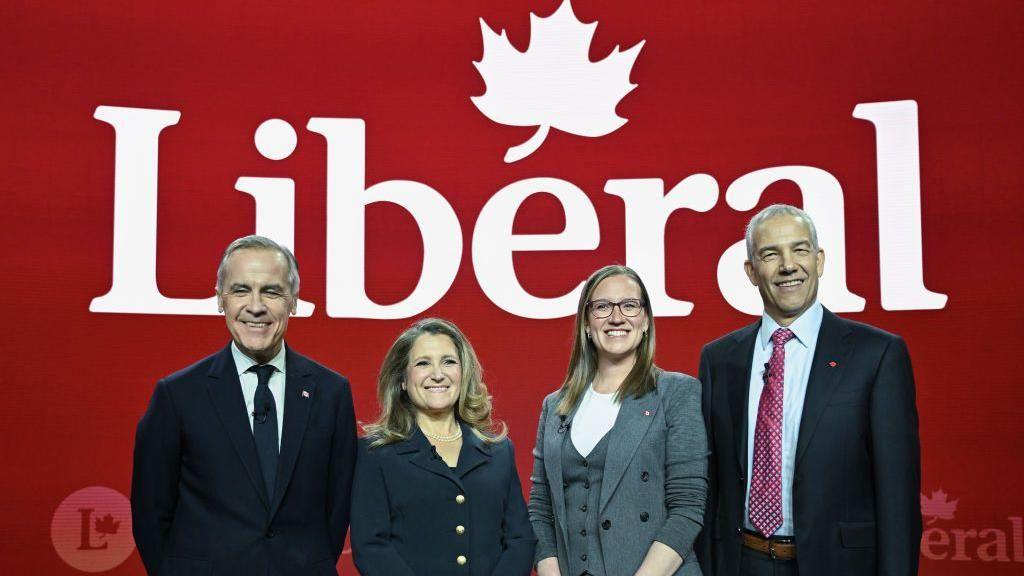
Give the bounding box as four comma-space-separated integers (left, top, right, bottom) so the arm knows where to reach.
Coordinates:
401, 334, 462, 415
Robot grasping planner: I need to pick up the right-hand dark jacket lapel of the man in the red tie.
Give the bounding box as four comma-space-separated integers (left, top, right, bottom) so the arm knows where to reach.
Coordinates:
794, 310, 853, 466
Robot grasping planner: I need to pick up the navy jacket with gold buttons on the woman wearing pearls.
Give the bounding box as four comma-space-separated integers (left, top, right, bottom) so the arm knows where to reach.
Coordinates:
352, 424, 537, 576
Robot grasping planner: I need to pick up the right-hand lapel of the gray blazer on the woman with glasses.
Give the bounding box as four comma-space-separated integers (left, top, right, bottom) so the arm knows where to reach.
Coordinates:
597, 388, 660, 515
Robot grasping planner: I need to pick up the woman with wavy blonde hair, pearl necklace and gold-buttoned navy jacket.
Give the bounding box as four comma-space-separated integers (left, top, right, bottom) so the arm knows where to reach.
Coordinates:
352, 318, 537, 576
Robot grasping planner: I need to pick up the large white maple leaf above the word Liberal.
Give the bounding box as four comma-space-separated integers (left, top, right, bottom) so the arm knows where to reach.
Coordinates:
470, 0, 644, 163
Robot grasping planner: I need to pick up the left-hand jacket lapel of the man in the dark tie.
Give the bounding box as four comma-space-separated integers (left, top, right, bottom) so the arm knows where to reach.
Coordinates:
207, 344, 269, 508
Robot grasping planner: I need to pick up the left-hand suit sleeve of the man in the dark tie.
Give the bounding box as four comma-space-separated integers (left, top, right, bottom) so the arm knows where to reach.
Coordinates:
131, 380, 181, 574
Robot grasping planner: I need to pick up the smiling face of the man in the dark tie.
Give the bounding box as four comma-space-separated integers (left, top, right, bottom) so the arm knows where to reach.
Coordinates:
217, 248, 296, 364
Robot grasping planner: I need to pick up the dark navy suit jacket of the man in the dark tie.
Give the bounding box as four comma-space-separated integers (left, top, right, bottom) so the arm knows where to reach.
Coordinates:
131, 345, 356, 576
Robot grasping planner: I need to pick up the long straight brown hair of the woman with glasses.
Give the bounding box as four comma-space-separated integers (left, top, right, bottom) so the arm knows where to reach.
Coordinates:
557, 264, 662, 414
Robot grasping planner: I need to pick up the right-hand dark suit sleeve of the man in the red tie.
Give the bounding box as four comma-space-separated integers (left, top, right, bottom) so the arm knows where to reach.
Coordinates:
870, 338, 922, 576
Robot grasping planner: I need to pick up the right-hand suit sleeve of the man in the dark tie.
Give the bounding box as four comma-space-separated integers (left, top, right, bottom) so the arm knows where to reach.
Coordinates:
327, 378, 356, 562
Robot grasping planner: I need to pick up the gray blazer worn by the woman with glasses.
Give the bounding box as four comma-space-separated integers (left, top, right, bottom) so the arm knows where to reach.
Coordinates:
529, 372, 708, 576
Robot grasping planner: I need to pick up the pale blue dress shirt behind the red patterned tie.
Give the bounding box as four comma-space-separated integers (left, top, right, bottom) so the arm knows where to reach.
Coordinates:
743, 301, 823, 536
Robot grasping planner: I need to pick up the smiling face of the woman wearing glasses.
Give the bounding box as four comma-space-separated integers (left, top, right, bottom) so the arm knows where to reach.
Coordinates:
587, 276, 649, 362
